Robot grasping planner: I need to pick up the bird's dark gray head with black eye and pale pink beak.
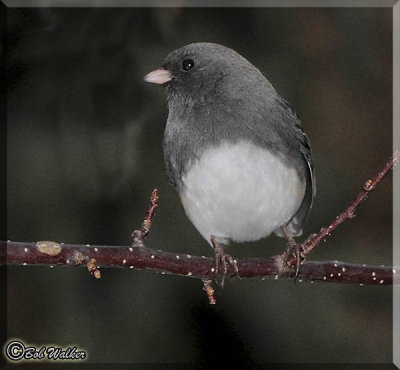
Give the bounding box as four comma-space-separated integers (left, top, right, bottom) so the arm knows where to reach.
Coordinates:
145, 42, 268, 102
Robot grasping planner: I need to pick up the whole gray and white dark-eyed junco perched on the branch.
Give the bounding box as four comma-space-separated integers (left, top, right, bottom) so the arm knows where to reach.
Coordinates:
145, 42, 315, 282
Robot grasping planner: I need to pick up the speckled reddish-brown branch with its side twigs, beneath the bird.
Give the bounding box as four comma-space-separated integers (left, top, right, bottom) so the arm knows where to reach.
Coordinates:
0, 150, 400, 296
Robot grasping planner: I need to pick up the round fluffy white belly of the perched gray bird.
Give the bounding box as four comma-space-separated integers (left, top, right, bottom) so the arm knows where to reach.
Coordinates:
180, 142, 305, 243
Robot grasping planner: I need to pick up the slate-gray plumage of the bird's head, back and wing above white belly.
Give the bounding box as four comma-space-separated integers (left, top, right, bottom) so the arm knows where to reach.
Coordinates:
158, 43, 315, 236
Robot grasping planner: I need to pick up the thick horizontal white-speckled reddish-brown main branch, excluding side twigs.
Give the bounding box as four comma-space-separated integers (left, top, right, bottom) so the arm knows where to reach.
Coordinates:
0, 241, 400, 285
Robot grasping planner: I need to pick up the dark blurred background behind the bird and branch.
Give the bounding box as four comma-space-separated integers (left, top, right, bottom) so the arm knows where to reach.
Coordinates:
7, 8, 392, 366
